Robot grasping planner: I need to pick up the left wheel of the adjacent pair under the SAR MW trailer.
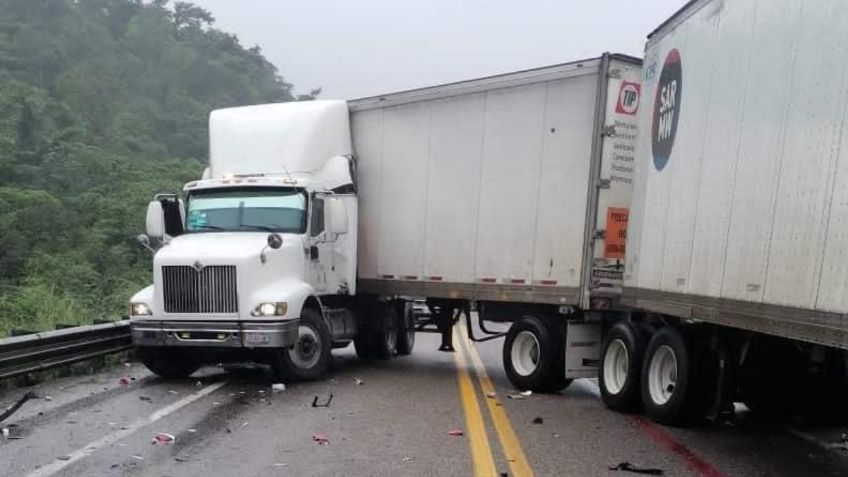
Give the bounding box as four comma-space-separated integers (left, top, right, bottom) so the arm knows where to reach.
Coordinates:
598, 321, 646, 412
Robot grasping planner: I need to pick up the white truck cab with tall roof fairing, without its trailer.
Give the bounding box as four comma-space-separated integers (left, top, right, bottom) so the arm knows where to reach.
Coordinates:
130, 101, 357, 379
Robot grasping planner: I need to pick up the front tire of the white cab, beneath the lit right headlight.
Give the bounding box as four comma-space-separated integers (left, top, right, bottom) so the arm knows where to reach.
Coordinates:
271, 308, 333, 381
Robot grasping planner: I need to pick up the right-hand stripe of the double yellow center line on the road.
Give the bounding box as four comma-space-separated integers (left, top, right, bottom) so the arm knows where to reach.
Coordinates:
457, 322, 534, 477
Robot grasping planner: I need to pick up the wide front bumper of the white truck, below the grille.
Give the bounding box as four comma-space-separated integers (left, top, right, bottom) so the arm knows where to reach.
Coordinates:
130, 319, 300, 349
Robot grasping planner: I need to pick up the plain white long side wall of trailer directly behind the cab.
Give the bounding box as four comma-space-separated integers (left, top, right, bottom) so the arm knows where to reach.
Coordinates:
351, 60, 599, 303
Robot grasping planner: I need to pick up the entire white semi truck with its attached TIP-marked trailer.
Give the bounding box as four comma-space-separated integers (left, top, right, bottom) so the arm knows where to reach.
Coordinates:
130, 54, 641, 390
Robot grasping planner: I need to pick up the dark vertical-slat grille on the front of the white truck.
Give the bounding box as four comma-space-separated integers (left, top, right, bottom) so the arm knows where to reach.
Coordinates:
162, 265, 238, 313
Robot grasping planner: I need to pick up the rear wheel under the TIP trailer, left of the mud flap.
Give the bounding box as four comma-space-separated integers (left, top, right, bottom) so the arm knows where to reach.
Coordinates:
503, 316, 571, 393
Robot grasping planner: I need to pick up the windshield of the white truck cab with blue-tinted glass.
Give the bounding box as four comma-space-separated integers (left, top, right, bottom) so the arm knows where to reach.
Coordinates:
186, 187, 306, 234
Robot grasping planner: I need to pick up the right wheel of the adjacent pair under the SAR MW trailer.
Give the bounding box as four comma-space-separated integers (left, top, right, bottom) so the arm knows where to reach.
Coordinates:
641, 326, 711, 426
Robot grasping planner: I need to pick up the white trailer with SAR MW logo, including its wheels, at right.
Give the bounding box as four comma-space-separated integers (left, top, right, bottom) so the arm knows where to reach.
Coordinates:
601, 0, 848, 423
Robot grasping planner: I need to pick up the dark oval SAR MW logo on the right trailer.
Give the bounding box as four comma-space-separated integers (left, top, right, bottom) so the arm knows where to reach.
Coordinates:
651, 49, 683, 171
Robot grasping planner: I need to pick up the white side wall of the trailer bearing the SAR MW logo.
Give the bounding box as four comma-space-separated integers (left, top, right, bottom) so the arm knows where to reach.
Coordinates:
625, 0, 848, 347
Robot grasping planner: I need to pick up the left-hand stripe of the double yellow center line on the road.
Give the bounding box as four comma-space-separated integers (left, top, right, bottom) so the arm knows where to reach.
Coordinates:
453, 328, 498, 477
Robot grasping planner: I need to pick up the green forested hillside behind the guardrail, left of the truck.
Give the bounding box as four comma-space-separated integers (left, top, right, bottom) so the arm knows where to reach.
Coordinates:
0, 0, 318, 336
